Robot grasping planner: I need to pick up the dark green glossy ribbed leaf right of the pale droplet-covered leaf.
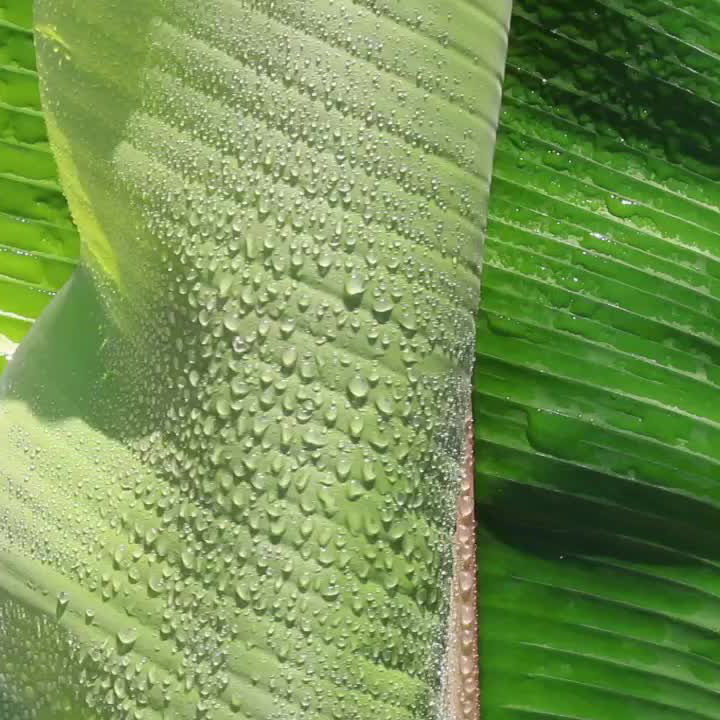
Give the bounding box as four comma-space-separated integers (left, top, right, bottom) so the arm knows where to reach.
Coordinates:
474, 0, 720, 720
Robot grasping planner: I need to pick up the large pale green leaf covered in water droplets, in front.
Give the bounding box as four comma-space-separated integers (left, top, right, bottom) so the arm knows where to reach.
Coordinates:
0, 0, 509, 720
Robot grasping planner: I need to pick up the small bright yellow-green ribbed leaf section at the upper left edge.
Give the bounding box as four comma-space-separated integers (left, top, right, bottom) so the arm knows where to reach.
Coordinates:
0, 0, 80, 372
